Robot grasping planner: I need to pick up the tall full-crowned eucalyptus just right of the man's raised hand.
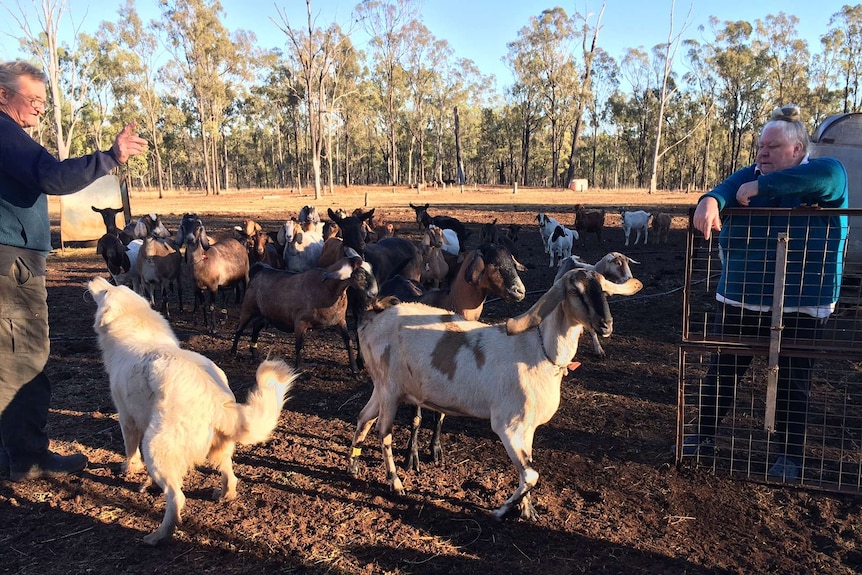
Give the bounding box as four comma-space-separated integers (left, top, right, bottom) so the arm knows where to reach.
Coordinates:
159, 0, 254, 194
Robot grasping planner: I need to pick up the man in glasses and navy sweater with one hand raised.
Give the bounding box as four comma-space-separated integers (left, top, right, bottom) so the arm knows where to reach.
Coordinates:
0, 61, 147, 481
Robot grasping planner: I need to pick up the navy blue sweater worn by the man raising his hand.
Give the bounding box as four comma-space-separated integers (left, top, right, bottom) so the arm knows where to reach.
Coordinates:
0, 112, 118, 255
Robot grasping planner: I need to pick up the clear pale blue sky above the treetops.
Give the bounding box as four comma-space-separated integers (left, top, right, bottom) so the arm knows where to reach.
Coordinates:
0, 0, 852, 87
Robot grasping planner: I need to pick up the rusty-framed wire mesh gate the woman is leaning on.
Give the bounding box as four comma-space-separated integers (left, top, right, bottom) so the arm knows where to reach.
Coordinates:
676, 209, 862, 491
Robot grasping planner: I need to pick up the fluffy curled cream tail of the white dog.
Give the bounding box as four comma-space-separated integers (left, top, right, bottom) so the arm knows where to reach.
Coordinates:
235, 360, 299, 445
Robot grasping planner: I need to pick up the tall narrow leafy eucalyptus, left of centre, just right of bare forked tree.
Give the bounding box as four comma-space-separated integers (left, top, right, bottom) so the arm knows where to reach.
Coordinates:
356, 0, 418, 185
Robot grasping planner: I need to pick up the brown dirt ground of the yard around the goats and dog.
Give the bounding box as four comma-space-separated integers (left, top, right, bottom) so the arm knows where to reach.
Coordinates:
0, 191, 862, 575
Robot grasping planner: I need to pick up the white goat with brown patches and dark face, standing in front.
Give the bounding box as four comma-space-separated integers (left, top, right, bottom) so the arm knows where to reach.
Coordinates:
348, 270, 642, 519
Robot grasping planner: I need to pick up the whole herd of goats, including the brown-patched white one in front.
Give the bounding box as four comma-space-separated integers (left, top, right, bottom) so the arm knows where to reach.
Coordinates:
86, 204, 671, 532
